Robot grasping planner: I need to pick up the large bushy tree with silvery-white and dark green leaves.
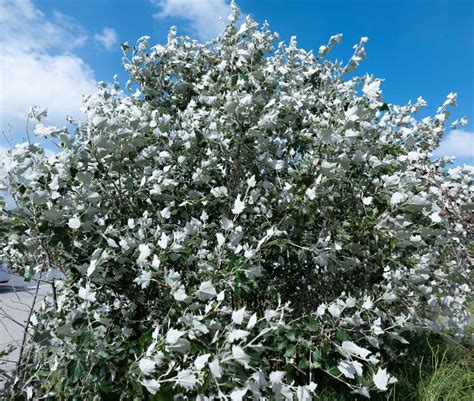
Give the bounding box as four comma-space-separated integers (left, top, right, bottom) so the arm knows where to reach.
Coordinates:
0, 6, 473, 401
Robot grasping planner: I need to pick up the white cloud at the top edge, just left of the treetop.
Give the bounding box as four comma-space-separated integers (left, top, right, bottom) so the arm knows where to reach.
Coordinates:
152, 0, 230, 40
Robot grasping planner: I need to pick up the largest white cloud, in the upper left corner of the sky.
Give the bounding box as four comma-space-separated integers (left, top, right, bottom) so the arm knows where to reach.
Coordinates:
0, 0, 96, 142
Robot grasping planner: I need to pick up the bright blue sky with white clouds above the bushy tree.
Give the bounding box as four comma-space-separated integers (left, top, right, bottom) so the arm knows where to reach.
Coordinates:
0, 0, 474, 163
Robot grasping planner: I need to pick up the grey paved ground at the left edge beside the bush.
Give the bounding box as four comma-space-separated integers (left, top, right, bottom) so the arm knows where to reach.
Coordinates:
0, 275, 50, 389
